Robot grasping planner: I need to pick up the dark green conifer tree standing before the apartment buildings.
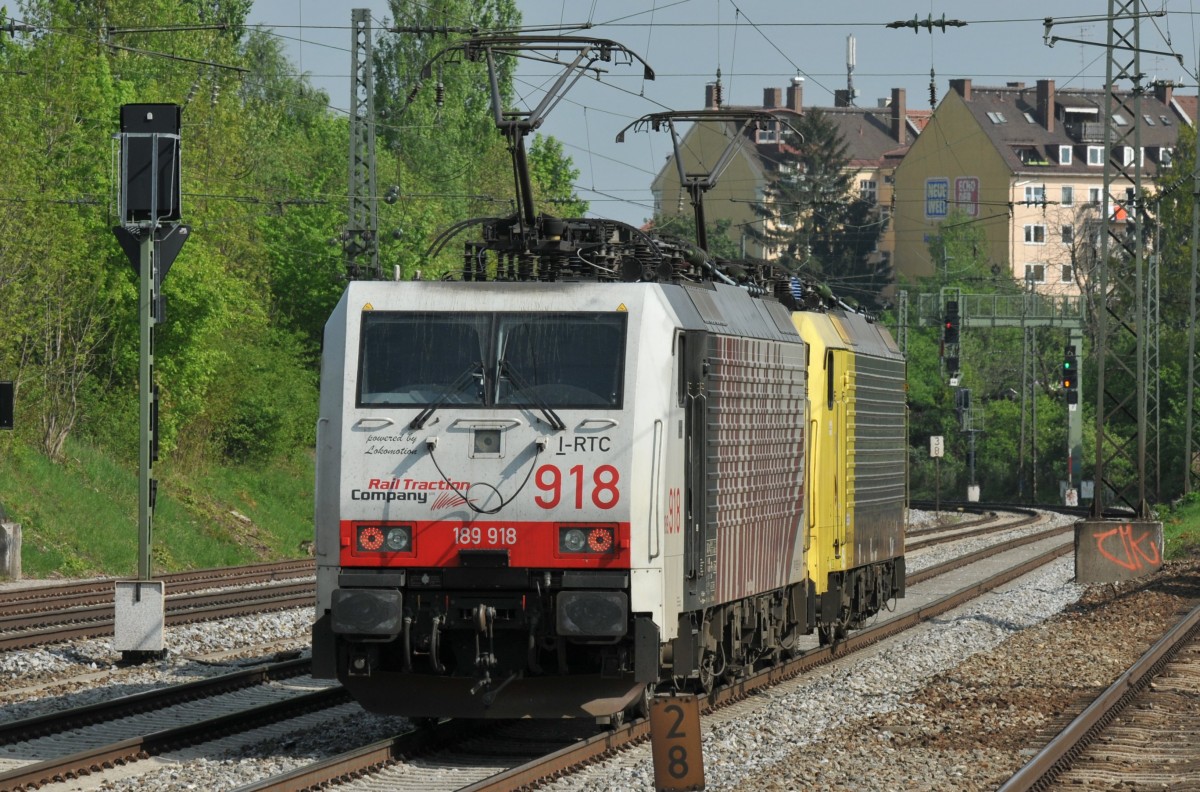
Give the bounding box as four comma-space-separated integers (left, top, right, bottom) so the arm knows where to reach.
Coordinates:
748, 109, 892, 307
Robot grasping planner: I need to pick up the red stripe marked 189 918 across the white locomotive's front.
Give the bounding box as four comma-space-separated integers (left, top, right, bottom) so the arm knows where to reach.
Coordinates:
340, 520, 630, 569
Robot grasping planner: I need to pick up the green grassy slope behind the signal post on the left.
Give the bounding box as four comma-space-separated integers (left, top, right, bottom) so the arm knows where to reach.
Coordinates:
0, 438, 313, 578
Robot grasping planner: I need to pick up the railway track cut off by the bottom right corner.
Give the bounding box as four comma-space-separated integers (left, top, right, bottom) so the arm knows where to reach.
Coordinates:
1000, 606, 1200, 792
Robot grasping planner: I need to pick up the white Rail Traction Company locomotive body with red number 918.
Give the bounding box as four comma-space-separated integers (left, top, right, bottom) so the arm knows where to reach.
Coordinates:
313, 274, 809, 718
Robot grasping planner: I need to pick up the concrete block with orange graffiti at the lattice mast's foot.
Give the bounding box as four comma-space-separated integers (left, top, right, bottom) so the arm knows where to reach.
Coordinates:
1075, 520, 1163, 583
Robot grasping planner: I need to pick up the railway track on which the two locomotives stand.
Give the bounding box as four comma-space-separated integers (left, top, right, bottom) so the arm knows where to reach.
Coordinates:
241, 511, 1073, 792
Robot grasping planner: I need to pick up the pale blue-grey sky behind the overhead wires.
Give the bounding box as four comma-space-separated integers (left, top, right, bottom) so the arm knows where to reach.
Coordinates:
250, 0, 1200, 224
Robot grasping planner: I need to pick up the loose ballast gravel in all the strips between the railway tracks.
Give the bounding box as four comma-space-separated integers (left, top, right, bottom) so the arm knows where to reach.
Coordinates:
0, 517, 1200, 792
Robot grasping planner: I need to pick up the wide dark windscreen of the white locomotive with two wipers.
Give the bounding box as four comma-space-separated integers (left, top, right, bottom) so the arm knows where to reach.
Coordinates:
358, 311, 626, 408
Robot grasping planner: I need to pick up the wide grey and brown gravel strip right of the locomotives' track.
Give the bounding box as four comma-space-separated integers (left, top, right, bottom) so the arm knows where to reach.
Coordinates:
546, 549, 1200, 792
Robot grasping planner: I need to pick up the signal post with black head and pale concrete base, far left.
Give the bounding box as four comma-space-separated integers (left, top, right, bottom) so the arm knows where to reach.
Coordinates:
113, 104, 190, 660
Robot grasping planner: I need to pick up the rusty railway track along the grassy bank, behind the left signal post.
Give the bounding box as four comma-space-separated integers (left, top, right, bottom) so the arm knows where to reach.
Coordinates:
0, 560, 314, 652
